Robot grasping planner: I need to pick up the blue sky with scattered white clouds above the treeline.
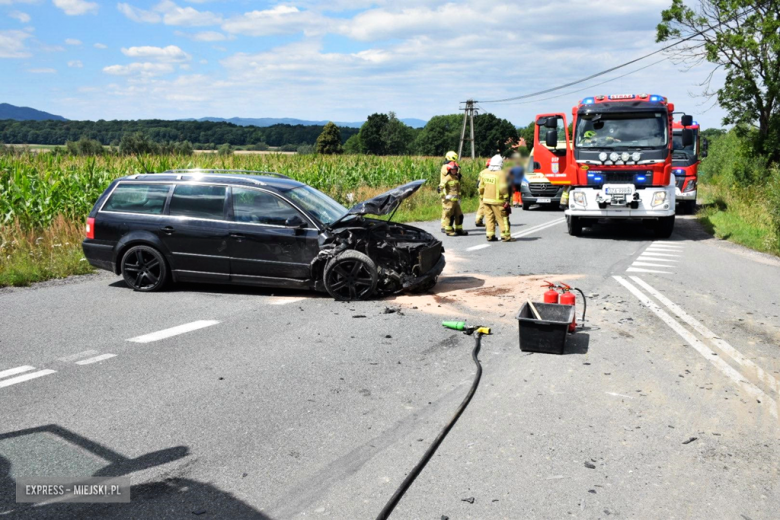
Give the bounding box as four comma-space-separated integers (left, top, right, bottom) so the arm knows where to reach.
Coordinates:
0, 0, 723, 126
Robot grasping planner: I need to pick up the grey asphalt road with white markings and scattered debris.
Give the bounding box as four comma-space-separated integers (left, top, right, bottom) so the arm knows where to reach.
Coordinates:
0, 210, 780, 520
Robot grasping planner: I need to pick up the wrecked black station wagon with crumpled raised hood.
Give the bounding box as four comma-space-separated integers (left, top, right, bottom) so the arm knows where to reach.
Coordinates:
83, 170, 444, 300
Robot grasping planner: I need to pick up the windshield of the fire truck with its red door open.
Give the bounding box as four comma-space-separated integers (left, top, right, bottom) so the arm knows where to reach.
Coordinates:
575, 112, 669, 149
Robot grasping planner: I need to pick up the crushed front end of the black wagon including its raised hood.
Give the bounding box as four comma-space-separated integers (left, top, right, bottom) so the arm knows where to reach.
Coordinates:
313, 180, 445, 299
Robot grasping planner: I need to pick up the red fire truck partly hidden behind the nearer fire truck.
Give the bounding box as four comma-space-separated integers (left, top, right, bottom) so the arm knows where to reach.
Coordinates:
672, 117, 709, 215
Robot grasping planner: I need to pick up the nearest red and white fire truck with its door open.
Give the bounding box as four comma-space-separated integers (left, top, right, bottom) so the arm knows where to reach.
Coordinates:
534, 94, 693, 238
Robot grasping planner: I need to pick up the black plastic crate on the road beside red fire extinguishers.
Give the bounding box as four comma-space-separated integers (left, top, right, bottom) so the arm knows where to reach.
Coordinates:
517, 302, 574, 354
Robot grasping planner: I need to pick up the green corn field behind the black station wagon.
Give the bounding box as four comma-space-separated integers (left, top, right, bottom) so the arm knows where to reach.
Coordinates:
0, 153, 484, 229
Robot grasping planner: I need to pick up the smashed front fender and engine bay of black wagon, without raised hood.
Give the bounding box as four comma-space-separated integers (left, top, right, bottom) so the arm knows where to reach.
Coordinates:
313, 217, 444, 295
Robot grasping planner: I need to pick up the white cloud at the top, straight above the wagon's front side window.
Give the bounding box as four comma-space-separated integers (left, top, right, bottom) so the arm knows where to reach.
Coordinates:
222, 5, 328, 36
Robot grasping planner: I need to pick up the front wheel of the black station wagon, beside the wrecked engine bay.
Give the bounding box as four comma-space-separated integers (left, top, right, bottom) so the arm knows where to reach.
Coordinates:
324, 250, 377, 301
